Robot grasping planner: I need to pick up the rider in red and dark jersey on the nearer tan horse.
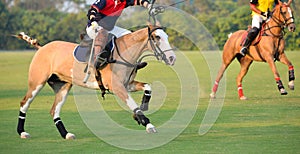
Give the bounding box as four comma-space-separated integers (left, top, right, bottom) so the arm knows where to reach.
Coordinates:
86, 0, 151, 69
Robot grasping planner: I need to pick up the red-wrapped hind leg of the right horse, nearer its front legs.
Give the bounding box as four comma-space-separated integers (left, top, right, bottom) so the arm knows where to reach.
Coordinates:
236, 57, 253, 100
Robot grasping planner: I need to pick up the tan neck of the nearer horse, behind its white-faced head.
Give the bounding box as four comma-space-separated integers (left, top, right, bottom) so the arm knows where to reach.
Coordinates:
117, 28, 148, 63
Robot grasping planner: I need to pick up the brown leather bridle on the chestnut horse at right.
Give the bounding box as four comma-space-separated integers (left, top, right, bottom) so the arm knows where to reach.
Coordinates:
264, 6, 294, 38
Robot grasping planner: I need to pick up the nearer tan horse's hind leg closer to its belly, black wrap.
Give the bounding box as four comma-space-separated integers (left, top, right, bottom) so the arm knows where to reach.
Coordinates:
48, 75, 75, 139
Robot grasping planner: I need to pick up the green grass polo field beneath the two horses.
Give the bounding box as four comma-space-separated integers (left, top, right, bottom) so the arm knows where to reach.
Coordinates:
0, 52, 300, 153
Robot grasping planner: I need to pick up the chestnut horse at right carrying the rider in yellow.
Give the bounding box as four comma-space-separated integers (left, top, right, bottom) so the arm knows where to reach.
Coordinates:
210, 3, 295, 100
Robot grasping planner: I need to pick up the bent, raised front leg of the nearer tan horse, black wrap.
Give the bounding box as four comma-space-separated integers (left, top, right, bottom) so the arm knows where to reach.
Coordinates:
128, 81, 152, 111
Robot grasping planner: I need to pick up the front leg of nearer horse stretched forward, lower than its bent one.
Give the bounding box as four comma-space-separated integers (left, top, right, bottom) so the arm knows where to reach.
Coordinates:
112, 83, 157, 133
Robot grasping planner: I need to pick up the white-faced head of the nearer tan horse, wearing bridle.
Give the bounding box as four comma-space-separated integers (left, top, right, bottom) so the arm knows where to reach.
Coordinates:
148, 26, 176, 65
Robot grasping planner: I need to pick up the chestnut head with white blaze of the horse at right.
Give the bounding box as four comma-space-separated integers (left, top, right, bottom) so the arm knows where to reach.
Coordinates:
274, 1, 296, 32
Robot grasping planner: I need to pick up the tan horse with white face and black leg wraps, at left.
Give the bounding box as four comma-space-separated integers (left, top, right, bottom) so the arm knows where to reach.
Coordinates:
17, 26, 176, 139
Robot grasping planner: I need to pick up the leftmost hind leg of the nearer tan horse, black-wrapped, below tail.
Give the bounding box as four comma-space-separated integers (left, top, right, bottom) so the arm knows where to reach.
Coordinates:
17, 84, 45, 138
